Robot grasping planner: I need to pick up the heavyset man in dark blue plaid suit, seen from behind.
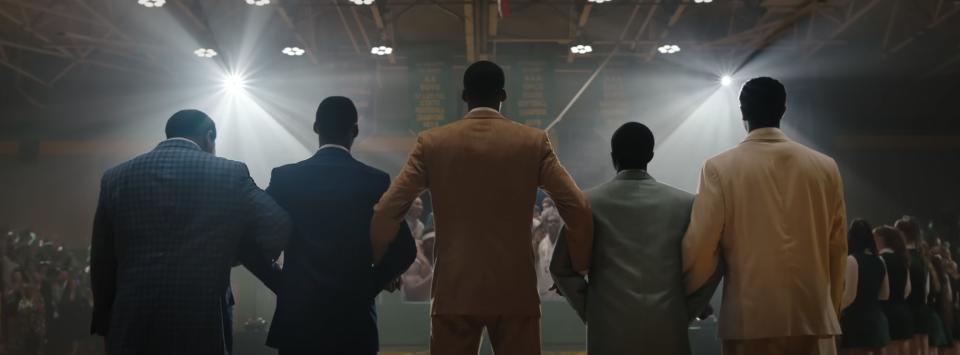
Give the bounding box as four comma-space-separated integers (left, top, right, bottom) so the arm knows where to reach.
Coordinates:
90, 110, 290, 355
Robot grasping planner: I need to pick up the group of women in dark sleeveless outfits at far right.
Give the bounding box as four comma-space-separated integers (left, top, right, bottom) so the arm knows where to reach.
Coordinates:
840, 216, 960, 355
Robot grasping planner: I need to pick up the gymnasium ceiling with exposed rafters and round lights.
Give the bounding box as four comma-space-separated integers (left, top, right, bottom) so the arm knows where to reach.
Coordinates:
0, 0, 960, 105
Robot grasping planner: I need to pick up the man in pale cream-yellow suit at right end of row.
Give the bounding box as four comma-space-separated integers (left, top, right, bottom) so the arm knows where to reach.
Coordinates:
683, 78, 847, 355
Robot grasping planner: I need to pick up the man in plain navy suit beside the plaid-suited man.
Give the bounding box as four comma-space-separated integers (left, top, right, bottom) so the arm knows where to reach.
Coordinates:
265, 97, 416, 355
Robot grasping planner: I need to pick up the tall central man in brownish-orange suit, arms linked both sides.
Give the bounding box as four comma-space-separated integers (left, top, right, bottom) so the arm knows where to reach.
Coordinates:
371, 61, 593, 355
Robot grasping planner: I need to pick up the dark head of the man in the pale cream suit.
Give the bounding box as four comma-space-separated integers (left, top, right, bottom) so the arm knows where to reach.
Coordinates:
740, 77, 787, 127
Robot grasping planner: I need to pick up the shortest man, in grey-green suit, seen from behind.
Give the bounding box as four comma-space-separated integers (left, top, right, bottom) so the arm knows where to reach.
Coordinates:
550, 122, 719, 355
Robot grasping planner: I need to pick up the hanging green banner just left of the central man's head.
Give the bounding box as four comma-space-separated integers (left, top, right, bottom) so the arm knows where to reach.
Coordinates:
410, 63, 457, 132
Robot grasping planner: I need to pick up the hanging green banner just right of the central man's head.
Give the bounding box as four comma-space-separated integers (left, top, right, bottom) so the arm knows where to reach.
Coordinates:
507, 61, 556, 128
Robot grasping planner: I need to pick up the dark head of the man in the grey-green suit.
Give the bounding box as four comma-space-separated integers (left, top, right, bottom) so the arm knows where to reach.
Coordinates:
610, 122, 656, 171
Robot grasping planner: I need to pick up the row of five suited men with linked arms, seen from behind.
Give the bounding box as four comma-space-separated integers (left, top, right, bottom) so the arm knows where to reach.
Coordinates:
91, 61, 846, 355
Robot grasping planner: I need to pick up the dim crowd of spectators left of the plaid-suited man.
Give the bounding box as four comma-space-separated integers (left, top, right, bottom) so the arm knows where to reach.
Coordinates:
0, 230, 101, 355
